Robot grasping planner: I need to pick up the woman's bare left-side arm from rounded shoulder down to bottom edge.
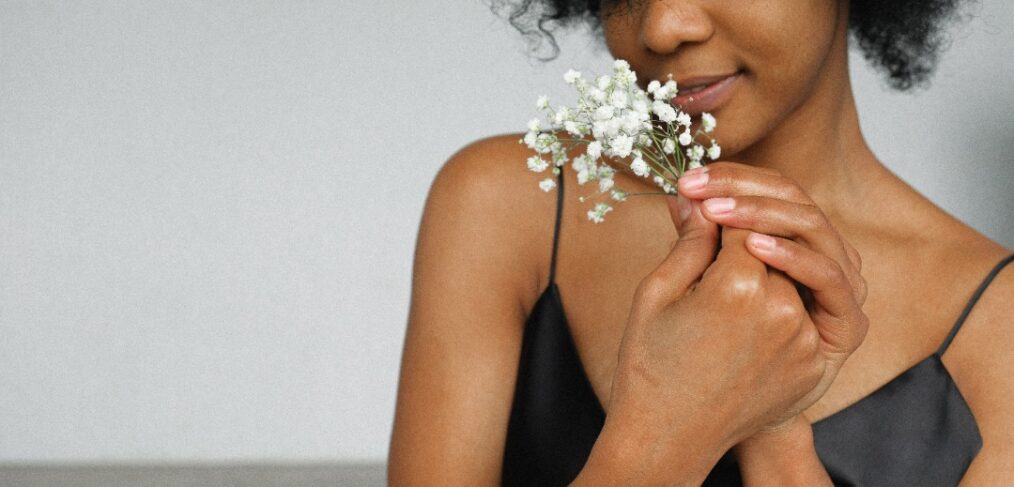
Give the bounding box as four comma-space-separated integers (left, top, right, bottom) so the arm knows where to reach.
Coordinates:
387, 137, 556, 486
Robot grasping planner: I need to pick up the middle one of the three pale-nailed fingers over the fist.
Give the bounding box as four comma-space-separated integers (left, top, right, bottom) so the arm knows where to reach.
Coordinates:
702, 196, 866, 301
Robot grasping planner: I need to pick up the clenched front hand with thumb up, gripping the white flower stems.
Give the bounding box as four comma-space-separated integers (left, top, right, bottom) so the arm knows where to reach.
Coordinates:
604, 187, 826, 473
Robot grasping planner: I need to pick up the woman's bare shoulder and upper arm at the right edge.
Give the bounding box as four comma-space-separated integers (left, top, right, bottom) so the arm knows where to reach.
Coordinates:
944, 232, 1014, 485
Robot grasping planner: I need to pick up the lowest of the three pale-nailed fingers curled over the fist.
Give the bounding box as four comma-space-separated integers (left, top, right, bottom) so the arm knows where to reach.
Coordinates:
747, 232, 865, 350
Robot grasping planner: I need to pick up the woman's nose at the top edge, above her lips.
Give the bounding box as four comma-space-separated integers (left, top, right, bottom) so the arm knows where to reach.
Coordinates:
641, 0, 715, 55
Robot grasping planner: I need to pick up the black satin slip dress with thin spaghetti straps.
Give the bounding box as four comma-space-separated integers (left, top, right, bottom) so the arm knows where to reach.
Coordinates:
501, 169, 1014, 487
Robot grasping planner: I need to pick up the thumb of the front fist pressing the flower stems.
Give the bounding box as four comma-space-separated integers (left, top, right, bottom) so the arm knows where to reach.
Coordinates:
651, 191, 719, 302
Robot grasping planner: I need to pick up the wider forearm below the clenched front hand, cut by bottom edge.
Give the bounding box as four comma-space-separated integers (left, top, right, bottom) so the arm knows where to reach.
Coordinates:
570, 407, 731, 487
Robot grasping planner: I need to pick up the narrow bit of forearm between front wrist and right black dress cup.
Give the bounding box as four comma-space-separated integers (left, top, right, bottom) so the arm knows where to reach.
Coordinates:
732, 416, 835, 487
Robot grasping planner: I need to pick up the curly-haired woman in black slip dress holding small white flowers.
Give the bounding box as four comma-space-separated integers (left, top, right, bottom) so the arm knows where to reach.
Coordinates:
388, 0, 1014, 485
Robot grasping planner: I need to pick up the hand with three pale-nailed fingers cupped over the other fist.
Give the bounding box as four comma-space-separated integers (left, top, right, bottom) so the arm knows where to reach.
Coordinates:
678, 162, 869, 429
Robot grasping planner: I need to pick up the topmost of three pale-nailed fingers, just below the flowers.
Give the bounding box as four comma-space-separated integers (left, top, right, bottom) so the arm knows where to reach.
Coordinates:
676, 161, 813, 204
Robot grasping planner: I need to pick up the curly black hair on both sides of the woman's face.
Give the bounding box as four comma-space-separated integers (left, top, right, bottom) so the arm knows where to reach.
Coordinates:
491, 0, 966, 91
